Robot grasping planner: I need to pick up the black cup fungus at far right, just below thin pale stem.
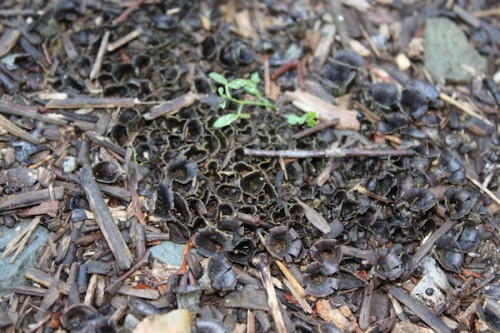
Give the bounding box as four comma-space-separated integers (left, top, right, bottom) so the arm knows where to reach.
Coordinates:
444, 186, 477, 220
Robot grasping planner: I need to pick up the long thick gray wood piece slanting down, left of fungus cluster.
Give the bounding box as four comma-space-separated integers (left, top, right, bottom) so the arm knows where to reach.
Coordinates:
80, 164, 132, 270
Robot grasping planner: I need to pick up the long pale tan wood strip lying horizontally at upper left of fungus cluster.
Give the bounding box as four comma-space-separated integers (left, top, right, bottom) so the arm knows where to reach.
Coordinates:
45, 97, 138, 109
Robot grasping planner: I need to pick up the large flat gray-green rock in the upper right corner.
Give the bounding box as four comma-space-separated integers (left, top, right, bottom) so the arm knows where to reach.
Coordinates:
424, 18, 486, 84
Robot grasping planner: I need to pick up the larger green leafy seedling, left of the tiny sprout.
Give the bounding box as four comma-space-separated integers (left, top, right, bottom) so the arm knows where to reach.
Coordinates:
208, 73, 275, 128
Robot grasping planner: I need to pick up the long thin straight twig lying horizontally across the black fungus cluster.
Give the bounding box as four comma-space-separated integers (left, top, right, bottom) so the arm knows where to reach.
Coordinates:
244, 148, 415, 158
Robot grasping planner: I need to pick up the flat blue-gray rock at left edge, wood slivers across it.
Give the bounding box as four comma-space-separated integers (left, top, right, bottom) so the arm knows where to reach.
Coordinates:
0, 220, 49, 296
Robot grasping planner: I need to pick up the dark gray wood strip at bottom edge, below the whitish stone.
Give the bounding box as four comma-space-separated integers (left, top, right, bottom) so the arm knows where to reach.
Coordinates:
388, 286, 451, 333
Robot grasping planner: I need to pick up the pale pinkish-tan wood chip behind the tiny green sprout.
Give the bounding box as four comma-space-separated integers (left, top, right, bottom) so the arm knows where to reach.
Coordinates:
285, 89, 360, 131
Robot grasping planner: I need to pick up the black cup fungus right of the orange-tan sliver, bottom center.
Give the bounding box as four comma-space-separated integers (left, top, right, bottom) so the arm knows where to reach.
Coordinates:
303, 262, 339, 297
